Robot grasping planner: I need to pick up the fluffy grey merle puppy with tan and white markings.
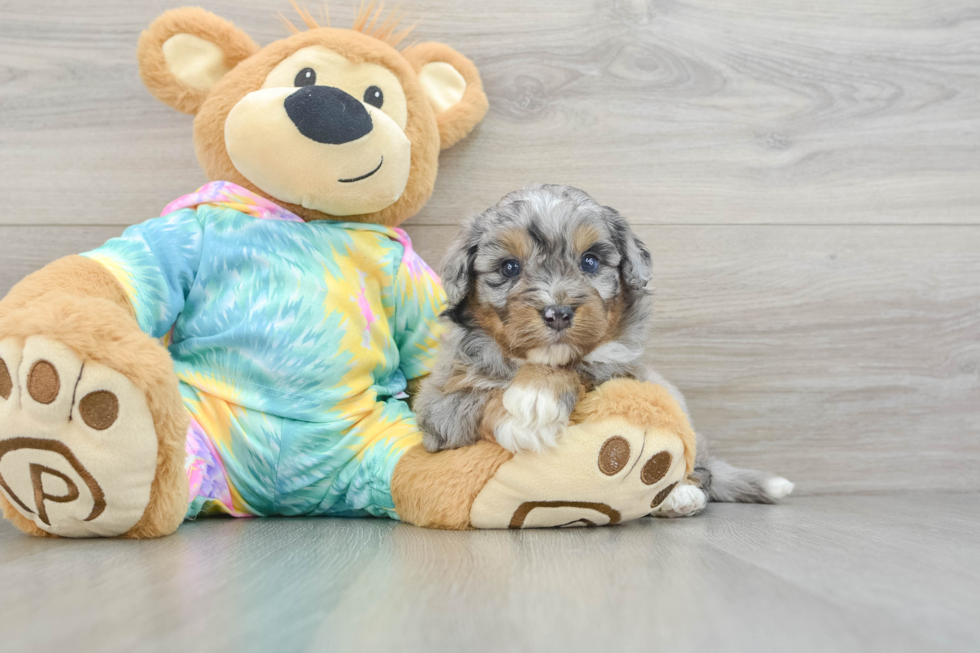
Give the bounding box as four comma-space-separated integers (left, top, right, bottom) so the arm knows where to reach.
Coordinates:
414, 185, 793, 516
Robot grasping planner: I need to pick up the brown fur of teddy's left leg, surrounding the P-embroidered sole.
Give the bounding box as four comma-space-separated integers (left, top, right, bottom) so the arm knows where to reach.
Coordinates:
0, 256, 189, 538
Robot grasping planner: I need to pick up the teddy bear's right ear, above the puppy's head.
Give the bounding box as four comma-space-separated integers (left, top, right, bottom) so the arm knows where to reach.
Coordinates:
403, 43, 488, 149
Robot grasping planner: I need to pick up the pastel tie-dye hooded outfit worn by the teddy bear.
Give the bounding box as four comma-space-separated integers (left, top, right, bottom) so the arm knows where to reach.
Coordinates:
84, 182, 444, 518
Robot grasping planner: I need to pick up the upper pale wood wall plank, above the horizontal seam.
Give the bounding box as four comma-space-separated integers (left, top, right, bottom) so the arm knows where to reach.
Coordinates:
0, 0, 980, 225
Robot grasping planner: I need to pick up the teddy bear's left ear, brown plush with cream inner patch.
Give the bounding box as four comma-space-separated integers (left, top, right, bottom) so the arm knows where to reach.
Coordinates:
136, 7, 259, 114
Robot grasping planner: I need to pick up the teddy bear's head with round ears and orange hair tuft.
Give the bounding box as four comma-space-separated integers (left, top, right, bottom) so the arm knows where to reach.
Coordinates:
138, 6, 487, 226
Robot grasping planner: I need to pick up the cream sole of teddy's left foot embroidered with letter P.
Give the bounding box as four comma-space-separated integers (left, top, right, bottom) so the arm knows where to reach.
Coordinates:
0, 337, 158, 537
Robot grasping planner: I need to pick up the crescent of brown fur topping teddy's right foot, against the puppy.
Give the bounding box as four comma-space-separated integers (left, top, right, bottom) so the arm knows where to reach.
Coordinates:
571, 379, 697, 474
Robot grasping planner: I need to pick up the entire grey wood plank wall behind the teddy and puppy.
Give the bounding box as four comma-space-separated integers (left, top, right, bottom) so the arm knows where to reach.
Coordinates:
0, 0, 980, 493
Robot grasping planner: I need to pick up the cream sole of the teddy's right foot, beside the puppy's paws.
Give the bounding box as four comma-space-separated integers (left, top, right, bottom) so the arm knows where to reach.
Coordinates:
470, 418, 685, 528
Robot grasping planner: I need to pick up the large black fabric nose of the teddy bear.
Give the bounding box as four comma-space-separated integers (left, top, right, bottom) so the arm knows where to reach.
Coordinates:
285, 86, 373, 145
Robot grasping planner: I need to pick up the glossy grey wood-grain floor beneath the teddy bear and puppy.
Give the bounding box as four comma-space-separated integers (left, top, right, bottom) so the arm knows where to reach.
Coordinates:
0, 493, 980, 653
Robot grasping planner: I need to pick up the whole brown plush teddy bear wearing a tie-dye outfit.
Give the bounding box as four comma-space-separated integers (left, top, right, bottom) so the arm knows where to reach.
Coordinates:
0, 8, 694, 538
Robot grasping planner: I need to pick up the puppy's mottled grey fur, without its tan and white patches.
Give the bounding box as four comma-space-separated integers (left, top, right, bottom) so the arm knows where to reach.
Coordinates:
414, 185, 792, 514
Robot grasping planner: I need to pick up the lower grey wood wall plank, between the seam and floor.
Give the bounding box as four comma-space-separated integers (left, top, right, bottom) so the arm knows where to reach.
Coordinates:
0, 225, 980, 494
